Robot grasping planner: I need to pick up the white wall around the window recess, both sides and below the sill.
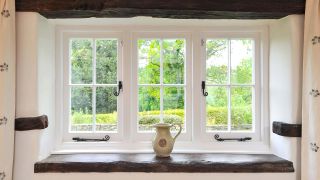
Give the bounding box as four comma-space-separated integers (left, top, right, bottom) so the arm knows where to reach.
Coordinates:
14, 13, 301, 180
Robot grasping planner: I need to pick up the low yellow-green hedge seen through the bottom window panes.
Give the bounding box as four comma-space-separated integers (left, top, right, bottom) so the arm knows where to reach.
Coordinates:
72, 106, 252, 126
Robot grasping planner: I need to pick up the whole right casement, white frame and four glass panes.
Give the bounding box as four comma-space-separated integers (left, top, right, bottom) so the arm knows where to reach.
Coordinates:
201, 32, 262, 141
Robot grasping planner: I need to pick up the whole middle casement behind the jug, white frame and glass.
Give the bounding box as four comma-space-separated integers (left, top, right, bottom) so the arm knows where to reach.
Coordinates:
131, 32, 192, 140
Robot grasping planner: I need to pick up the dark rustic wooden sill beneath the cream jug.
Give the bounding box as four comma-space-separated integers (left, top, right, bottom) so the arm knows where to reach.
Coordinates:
34, 154, 294, 173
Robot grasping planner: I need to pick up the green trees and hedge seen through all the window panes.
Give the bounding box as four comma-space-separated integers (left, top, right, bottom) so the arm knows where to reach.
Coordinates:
70, 39, 253, 131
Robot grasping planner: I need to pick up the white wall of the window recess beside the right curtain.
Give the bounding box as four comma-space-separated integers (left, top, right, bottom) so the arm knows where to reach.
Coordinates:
269, 15, 304, 180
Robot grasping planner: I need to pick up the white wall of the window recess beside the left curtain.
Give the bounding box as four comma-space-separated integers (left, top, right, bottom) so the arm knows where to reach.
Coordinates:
14, 13, 55, 180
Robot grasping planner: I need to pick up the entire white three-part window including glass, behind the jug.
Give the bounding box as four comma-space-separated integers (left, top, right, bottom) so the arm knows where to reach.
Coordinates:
56, 26, 269, 151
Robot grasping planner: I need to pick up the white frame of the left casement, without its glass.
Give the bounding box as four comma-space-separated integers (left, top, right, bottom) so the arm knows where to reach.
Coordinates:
57, 31, 124, 145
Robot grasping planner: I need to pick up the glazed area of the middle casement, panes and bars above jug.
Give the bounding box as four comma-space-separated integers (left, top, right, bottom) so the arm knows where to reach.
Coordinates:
137, 38, 186, 132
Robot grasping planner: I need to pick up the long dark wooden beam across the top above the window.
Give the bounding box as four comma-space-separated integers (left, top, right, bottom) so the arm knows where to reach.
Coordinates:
16, 0, 305, 19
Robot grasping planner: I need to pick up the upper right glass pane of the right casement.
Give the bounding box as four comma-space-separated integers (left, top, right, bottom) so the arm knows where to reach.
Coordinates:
231, 39, 254, 84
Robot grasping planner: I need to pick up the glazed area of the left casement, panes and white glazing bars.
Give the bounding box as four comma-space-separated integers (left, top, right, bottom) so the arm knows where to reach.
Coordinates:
68, 38, 118, 133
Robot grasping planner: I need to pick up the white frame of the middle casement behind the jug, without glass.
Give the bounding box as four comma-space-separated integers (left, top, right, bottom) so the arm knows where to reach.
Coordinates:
131, 31, 192, 141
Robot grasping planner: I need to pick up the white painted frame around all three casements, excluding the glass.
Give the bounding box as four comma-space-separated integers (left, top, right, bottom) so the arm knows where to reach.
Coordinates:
54, 24, 270, 153
